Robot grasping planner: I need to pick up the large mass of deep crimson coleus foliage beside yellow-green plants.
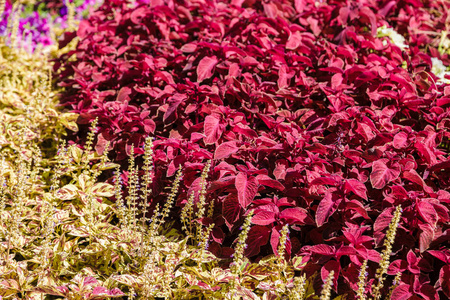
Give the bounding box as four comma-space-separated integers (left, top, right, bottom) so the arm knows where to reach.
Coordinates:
56, 0, 450, 299
